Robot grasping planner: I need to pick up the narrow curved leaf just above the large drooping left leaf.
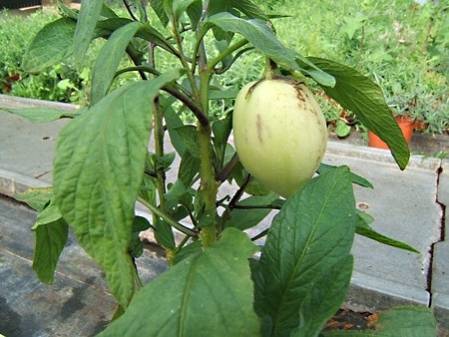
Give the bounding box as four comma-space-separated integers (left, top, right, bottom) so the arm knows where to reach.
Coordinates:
91, 22, 142, 105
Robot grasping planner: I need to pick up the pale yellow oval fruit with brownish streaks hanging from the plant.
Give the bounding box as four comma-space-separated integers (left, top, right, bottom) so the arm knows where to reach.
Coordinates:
233, 79, 327, 197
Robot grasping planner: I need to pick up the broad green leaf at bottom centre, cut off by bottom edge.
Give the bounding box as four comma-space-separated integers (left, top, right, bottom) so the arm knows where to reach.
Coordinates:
97, 229, 259, 337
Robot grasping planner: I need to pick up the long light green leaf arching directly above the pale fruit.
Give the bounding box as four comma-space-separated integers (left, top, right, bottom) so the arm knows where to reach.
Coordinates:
207, 13, 335, 86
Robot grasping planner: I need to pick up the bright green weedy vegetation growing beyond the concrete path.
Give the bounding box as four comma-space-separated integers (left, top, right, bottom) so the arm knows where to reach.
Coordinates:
0, 0, 449, 133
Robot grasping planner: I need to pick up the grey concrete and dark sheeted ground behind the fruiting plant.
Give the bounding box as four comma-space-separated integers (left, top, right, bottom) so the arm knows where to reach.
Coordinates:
0, 97, 449, 337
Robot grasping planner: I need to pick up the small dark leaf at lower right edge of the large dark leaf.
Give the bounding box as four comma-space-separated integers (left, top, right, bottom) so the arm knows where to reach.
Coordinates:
291, 255, 354, 337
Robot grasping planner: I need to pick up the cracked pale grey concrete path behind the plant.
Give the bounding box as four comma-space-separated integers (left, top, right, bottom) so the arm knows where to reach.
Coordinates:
0, 103, 449, 331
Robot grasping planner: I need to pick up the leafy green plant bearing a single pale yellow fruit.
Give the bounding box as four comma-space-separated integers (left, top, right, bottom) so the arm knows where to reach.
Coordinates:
6, 0, 435, 337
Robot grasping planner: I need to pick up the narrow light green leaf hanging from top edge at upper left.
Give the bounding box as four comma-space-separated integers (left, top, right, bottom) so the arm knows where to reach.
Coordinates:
73, 0, 103, 68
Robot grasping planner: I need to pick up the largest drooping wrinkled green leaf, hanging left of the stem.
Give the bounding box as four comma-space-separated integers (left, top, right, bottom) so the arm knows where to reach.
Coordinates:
54, 71, 179, 307
